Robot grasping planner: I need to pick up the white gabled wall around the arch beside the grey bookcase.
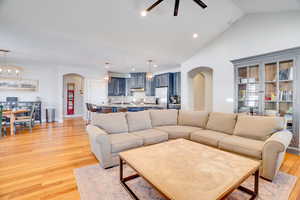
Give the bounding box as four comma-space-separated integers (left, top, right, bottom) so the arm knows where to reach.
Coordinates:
181, 12, 300, 112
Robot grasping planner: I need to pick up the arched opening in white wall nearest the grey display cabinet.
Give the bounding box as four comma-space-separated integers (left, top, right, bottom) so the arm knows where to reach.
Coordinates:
188, 67, 213, 111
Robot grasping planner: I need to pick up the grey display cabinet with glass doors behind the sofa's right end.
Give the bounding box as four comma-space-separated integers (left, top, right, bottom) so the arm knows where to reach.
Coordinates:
232, 48, 300, 147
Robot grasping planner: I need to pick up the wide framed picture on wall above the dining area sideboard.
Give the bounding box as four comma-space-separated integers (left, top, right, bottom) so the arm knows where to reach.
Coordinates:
0, 78, 39, 92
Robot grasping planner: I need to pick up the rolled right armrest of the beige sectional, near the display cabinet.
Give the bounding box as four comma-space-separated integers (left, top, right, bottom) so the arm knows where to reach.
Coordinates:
262, 130, 293, 180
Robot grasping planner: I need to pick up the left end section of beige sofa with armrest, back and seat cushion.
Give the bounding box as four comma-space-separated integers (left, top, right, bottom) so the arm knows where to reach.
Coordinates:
87, 113, 143, 168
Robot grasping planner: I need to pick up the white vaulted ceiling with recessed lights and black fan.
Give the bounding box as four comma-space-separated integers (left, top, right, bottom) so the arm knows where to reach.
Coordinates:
0, 0, 299, 72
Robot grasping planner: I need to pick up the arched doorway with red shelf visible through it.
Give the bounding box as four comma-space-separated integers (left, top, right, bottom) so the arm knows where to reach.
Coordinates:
63, 73, 84, 117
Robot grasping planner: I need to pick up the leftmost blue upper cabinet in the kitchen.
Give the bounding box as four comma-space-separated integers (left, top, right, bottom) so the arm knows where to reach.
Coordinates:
108, 77, 126, 96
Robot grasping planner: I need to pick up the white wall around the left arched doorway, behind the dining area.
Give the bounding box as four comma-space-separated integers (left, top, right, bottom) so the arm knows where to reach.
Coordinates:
0, 60, 107, 122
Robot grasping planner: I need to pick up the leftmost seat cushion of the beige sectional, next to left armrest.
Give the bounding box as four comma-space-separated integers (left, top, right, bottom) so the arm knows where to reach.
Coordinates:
108, 133, 143, 153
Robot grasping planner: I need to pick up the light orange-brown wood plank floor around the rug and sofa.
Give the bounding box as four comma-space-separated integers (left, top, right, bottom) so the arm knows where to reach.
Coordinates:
0, 118, 300, 200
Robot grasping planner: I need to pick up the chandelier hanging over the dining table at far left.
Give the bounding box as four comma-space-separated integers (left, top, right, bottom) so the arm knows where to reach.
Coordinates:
0, 49, 22, 78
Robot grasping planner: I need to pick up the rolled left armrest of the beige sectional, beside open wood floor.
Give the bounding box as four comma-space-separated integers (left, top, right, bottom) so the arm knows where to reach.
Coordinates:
86, 125, 112, 168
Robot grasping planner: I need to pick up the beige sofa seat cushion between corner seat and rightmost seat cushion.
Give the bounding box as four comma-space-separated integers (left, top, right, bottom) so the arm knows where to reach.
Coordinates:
191, 130, 230, 147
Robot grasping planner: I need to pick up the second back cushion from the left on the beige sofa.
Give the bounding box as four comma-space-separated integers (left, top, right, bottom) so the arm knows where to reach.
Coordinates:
126, 111, 152, 132
